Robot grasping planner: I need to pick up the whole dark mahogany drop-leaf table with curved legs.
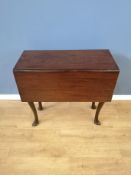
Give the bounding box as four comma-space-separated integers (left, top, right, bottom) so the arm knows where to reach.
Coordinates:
13, 50, 119, 126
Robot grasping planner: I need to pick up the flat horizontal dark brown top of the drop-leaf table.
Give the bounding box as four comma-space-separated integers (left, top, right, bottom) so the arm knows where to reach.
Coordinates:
14, 50, 119, 72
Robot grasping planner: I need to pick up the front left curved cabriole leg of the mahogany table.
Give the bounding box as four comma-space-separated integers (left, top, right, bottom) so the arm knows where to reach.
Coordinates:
28, 102, 39, 126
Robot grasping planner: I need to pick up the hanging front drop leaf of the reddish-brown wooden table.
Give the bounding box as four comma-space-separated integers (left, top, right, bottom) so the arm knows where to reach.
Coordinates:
14, 71, 118, 102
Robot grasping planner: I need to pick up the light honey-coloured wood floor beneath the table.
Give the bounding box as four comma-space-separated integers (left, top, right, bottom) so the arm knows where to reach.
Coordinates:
0, 101, 131, 175
